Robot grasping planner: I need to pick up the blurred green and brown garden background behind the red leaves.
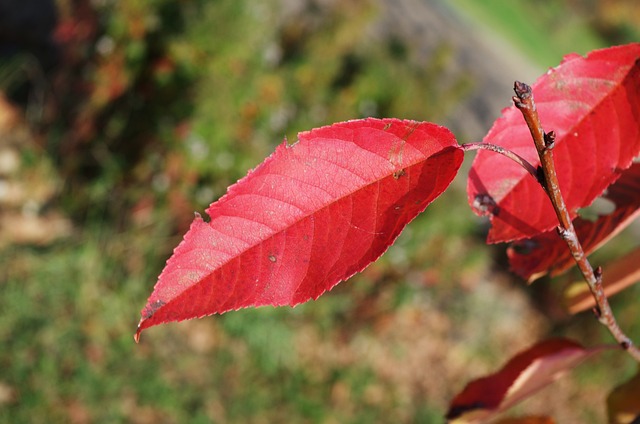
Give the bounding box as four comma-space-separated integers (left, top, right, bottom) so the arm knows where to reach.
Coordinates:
0, 0, 640, 423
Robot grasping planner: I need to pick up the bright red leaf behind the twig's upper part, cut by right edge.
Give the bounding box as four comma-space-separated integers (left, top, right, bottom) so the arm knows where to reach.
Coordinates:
467, 43, 640, 243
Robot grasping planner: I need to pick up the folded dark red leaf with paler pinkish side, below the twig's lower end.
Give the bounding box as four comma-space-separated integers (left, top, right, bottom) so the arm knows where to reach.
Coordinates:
446, 339, 617, 423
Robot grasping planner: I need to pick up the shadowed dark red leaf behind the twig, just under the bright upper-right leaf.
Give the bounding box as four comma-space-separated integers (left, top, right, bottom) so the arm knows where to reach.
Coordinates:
507, 163, 640, 281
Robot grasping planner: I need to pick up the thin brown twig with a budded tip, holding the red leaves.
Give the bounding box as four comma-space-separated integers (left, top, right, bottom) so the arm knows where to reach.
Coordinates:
513, 81, 640, 362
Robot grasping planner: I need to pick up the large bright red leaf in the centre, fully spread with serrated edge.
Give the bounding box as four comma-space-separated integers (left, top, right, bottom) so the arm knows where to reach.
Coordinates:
136, 119, 463, 337
